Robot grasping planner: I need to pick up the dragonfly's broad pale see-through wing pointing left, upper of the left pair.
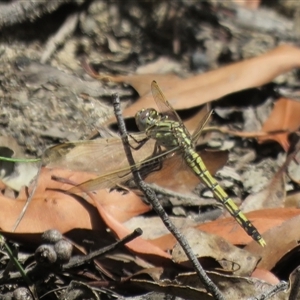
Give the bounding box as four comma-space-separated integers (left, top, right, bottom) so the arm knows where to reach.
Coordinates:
42, 134, 155, 174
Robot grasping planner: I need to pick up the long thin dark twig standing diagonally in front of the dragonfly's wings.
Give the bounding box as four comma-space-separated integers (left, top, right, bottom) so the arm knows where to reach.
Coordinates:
112, 94, 224, 300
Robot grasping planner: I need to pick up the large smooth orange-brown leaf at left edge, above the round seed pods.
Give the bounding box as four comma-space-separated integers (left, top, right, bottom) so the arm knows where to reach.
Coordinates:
0, 172, 103, 233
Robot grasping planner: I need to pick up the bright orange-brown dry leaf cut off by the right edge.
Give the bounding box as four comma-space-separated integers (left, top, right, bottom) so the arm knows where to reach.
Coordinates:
258, 98, 300, 151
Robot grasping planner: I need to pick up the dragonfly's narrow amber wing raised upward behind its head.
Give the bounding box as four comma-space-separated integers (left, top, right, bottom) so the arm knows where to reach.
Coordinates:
151, 80, 183, 125
